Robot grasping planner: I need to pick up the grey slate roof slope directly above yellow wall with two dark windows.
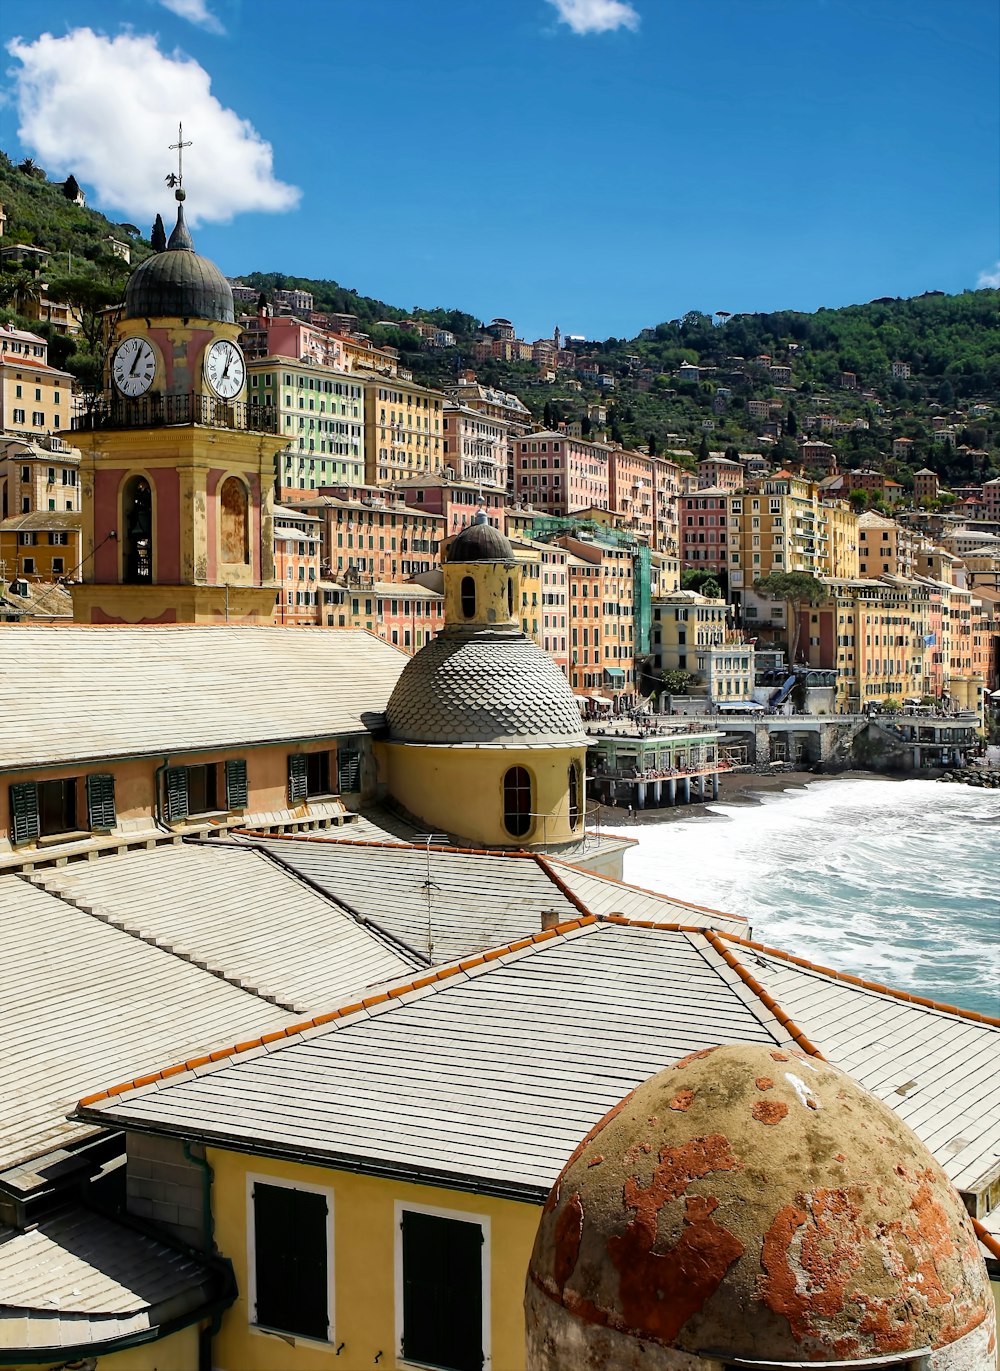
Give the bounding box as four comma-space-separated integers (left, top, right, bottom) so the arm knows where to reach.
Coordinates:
84, 923, 790, 1200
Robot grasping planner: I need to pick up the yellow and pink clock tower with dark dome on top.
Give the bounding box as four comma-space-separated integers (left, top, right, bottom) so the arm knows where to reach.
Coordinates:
73, 160, 283, 624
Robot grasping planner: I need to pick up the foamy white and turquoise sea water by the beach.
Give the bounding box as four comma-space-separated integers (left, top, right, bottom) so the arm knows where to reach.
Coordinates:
600, 779, 1000, 1015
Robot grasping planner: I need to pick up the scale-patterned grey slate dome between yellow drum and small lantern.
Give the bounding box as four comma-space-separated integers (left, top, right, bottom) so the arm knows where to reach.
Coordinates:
385, 631, 586, 746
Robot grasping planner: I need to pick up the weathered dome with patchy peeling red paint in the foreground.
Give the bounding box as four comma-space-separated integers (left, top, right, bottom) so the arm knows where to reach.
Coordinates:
525, 1045, 996, 1371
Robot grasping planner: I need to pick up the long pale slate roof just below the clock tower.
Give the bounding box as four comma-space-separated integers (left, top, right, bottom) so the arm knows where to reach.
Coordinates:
0, 624, 410, 771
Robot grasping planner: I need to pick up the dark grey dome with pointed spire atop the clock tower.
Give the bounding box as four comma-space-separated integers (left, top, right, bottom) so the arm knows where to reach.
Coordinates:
125, 203, 236, 324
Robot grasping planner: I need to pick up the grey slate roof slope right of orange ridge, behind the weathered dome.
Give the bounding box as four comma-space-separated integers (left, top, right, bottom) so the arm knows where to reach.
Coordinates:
728, 943, 1000, 1190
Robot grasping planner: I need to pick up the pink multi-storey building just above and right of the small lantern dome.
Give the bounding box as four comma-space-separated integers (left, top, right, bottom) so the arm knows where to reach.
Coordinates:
514, 432, 612, 514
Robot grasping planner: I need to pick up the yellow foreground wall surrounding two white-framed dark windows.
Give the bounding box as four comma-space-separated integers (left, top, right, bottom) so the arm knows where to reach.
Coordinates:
207, 1148, 540, 1371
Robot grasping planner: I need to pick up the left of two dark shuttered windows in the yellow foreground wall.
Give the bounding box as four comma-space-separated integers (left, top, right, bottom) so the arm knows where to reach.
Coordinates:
254, 1183, 333, 1339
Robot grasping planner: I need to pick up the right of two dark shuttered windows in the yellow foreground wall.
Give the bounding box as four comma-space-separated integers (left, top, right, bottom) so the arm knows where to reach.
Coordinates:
401, 1209, 484, 1371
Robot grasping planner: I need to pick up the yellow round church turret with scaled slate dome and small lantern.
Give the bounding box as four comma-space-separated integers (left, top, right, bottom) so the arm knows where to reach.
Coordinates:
376, 514, 586, 847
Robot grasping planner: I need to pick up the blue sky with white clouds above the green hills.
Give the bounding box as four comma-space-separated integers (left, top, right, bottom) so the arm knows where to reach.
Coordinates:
0, 0, 1000, 339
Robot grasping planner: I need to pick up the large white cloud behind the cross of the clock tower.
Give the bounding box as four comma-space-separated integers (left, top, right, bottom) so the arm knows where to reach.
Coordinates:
7, 29, 300, 232
